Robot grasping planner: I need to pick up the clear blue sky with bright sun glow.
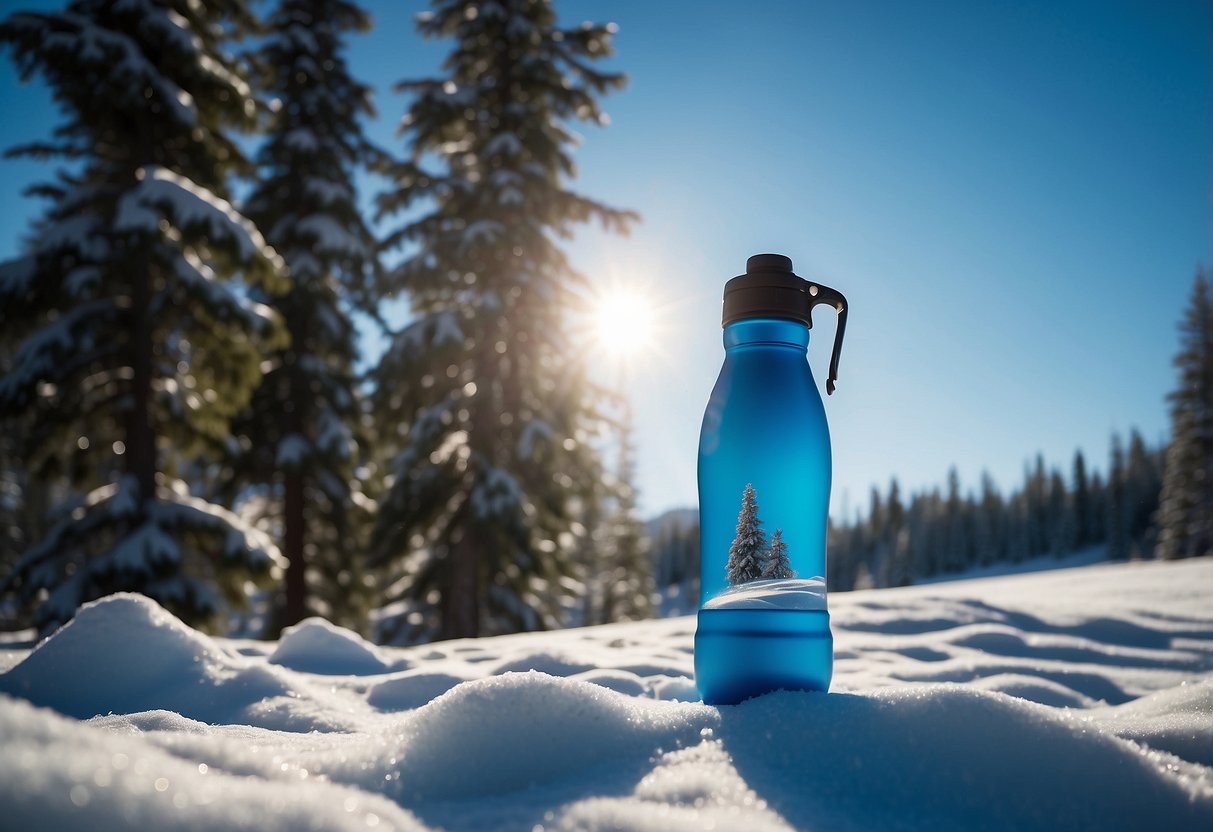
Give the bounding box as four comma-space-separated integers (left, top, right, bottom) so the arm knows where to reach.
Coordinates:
0, 0, 1213, 519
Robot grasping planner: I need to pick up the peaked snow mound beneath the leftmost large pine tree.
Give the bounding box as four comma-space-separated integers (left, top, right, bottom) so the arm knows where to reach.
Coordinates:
0, 593, 291, 722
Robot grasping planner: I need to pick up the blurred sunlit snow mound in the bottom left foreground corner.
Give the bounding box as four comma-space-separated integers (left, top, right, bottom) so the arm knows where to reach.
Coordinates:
0, 696, 427, 832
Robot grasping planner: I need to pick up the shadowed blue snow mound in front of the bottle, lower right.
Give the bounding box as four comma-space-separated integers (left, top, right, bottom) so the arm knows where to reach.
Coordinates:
717, 685, 1213, 830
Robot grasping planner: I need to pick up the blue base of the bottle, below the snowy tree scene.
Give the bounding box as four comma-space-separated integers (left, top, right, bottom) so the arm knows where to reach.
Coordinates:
695, 609, 833, 705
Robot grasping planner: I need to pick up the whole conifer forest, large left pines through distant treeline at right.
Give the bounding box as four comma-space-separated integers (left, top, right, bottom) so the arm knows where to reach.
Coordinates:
0, 0, 1213, 644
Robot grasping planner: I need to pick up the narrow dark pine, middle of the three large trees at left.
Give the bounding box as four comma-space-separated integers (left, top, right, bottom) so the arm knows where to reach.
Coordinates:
220, 0, 381, 628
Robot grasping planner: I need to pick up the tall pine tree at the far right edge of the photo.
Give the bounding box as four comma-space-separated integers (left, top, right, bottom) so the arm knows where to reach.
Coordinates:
1156, 270, 1213, 559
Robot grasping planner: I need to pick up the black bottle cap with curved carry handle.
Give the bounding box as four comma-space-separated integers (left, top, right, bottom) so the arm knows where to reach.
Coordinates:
722, 255, 847, 393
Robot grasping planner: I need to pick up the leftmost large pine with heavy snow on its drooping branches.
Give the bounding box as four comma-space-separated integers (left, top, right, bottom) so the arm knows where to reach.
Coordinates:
0, 0, 280, 628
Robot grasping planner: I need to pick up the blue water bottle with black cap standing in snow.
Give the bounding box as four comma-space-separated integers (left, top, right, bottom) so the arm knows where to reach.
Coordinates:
695, 255, 847, 705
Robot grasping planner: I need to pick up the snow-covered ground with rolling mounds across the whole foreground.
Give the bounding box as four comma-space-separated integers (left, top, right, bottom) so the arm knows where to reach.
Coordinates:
0, 559, 1213, 832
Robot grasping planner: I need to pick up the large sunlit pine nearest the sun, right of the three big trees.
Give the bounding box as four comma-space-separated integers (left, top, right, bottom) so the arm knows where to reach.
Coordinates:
374, 0, 634, 639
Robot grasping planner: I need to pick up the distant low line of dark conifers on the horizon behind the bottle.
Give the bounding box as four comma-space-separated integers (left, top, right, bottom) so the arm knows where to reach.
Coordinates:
653, 431, 1164, 599
